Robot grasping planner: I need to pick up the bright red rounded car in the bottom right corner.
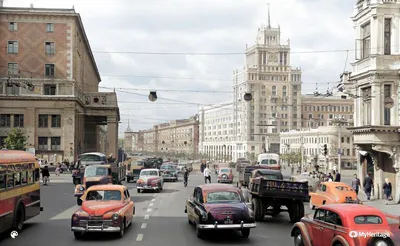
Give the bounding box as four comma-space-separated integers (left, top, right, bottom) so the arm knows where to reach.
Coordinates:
291, 203, 398, 246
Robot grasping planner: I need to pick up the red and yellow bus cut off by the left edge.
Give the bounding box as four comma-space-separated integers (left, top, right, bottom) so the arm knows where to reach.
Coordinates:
0, 150, 43, 233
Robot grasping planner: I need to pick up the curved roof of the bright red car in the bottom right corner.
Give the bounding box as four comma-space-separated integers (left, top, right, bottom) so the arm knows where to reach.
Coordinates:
319, 203, 385, 219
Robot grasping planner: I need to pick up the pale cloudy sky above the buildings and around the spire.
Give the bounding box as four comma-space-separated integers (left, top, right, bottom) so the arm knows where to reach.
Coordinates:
4, 0, 356, 137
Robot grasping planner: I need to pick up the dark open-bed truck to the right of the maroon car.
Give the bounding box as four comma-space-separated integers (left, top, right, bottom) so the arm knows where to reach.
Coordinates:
249, 177, 309, 223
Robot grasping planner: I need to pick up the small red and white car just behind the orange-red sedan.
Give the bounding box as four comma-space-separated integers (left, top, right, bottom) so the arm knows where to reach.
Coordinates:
136, 168, 164, 193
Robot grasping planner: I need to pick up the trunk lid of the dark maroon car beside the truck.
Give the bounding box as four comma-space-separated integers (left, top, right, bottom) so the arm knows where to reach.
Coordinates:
204, 203, 249, 221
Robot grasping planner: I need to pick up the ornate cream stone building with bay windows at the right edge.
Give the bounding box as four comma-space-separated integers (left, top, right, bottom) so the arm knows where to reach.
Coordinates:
345, 0, 400, 202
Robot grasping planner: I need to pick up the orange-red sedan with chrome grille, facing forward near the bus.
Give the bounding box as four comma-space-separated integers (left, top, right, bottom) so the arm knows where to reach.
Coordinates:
71, 184, 135, 239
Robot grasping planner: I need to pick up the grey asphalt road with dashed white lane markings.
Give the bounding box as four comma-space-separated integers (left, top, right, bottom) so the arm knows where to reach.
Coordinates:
0, 171, 309, 246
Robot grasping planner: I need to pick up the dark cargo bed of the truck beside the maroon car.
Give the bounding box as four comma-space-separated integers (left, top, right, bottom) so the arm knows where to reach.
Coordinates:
249, 177, 309, 202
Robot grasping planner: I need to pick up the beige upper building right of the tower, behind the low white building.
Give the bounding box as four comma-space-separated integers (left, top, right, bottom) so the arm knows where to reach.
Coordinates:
301, 93, 354, 128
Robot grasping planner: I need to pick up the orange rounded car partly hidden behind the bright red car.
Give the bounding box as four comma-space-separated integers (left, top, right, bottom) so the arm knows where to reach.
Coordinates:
309, 182, 361, 209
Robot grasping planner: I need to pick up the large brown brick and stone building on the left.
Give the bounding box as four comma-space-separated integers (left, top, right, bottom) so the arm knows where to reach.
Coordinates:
0, 6, 119, 162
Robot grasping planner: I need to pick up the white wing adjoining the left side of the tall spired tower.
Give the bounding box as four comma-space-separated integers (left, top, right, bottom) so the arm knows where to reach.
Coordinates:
199, 102, 239, 161
